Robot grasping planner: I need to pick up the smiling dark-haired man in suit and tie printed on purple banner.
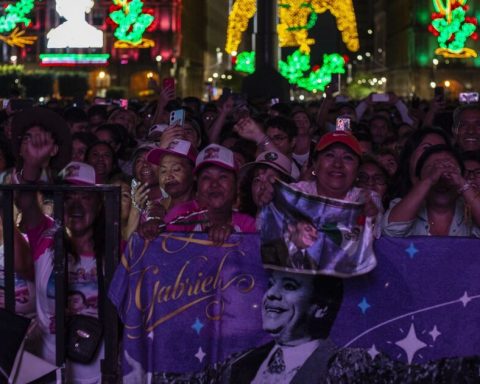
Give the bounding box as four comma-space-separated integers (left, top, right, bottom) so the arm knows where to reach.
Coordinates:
224, 271, 343, 384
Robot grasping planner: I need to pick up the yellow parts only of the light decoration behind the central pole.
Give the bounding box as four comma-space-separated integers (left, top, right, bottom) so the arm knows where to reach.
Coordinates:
225, 0, 360, 54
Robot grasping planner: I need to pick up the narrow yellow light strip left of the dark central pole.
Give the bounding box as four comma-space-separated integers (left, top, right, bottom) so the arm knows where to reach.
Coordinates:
225, 0, 257, 54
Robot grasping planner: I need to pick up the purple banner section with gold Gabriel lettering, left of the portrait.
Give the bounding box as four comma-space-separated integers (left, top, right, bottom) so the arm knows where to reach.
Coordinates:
109, 233, 269, 383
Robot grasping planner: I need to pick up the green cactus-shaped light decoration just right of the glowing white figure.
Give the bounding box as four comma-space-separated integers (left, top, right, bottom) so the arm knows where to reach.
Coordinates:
109, 0, 155, 48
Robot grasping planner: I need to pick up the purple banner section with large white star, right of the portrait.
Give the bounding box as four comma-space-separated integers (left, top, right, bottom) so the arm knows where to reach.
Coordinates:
332, 237, 480, 364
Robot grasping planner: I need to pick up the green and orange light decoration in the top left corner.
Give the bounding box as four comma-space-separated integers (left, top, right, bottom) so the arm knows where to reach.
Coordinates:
0, 0, 37, 48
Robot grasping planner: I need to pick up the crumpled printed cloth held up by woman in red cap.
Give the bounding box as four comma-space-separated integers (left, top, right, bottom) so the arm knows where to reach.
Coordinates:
261, 181, 376, 277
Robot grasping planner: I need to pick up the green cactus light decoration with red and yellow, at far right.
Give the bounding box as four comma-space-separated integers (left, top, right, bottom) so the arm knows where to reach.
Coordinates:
428, 0, 478, 58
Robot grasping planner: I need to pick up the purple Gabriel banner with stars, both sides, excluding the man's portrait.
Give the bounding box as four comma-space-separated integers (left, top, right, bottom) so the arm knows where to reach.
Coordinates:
109, 233, 480, 383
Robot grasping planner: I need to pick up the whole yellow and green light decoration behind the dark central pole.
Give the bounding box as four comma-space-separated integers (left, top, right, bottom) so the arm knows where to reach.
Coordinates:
225, 0, 359, 91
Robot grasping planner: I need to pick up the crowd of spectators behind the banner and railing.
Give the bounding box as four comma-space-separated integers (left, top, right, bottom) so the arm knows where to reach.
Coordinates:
0, 89, 480, 383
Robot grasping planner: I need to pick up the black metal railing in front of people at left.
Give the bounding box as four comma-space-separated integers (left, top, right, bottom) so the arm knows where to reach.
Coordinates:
0, 185, 121, 383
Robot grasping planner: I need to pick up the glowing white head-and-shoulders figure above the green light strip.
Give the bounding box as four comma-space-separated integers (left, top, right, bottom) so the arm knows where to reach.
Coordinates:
47, 0, 103, 48
